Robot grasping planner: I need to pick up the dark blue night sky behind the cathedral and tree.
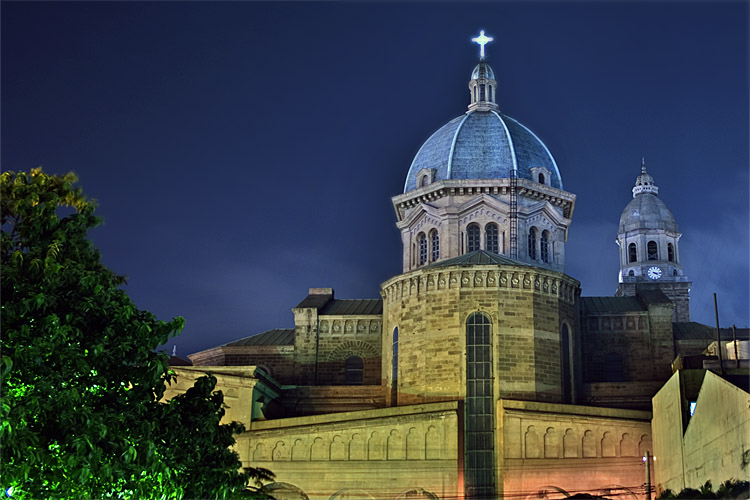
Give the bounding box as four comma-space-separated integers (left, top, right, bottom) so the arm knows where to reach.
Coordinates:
0, 2, 750, 355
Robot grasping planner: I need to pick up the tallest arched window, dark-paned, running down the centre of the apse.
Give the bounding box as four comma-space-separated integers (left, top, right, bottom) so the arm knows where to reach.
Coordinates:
464, 312, 497, 498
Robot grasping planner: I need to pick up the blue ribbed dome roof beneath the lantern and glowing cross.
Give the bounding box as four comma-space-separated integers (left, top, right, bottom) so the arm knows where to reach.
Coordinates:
404, 111, 563, 192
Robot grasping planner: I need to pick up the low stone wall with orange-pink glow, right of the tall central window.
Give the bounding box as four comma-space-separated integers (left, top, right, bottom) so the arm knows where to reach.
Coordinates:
497, 400, 651, 500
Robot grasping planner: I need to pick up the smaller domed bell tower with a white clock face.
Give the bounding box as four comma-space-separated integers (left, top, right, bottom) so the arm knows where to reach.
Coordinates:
616, 162, 691, 321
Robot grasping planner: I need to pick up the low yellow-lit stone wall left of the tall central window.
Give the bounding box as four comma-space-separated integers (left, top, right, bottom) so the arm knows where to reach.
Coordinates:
242, 403, 459, 500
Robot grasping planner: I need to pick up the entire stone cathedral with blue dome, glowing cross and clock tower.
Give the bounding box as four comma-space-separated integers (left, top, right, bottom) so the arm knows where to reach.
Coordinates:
166, 34, 740, 500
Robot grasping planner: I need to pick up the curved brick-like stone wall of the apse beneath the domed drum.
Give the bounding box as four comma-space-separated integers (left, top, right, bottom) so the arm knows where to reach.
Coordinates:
381, 266, 579, 405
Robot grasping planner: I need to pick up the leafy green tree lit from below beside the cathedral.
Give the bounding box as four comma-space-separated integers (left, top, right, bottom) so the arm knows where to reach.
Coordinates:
0, 169, 270, 499
